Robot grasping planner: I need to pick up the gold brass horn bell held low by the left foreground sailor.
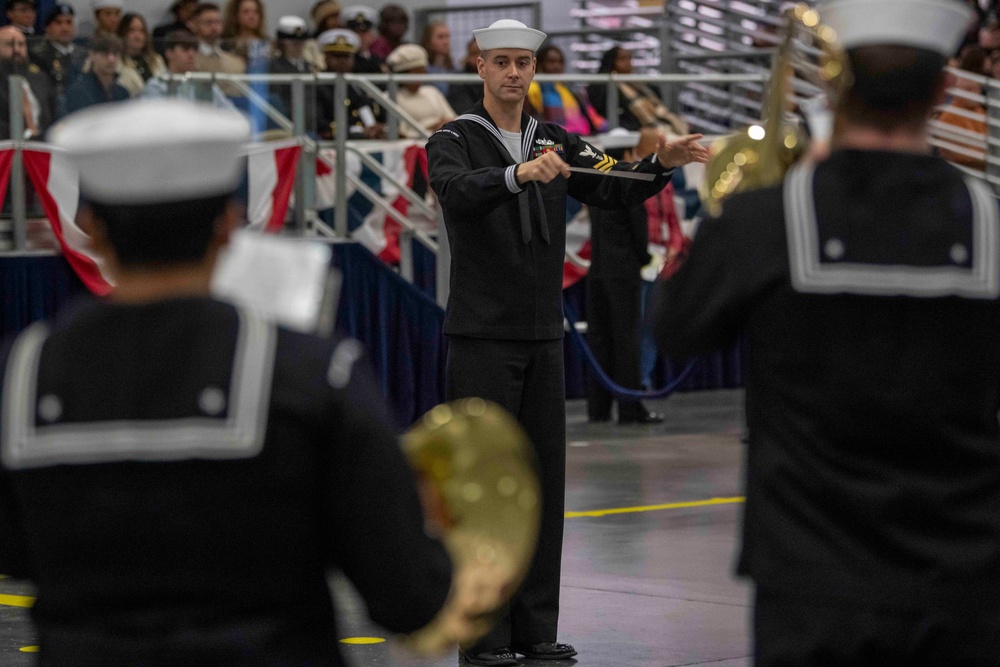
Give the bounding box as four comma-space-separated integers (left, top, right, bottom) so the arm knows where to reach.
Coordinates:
403, 398, 541, 655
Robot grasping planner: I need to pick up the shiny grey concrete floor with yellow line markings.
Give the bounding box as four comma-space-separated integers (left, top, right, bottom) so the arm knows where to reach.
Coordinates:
0, 391, 752, 667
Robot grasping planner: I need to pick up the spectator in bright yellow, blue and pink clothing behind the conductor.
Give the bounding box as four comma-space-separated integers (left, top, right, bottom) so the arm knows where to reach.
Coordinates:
524, 44, 608, 136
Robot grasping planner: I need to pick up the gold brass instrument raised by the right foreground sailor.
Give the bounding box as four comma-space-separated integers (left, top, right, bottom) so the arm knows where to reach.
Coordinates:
700, 3, 850, 216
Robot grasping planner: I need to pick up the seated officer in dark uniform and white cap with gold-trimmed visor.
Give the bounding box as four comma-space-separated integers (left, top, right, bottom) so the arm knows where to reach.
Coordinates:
316, 28, 385, 139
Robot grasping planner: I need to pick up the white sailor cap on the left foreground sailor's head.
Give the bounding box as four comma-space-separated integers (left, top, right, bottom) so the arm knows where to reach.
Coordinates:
48, 99, 250, 204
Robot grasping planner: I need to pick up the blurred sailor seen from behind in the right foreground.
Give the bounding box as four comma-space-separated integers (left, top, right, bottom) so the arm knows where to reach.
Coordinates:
656, 0, 1000, 667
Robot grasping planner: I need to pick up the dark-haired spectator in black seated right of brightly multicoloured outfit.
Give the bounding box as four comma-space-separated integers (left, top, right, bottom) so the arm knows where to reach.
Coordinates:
587, 46, 689, 147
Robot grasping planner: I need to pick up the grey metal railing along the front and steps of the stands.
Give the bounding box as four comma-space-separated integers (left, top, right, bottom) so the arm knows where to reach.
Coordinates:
9, 61, 1000, 304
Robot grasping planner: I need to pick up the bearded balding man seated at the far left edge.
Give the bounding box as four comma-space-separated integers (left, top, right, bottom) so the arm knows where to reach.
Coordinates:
0, 26, 56, 139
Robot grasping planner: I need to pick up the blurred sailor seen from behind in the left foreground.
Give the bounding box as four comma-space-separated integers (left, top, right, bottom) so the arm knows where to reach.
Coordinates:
0, 100, 499, 666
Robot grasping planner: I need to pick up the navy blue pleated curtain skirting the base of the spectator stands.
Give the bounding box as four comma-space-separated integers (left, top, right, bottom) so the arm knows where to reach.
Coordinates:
0, 243, 746, 427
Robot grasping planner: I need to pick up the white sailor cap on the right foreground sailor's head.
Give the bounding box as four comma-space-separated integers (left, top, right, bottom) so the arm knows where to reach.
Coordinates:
818, 0, 973, 58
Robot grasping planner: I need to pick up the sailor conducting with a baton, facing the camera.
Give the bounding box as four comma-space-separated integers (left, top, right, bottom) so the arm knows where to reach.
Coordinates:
427, 20, 707, 666
